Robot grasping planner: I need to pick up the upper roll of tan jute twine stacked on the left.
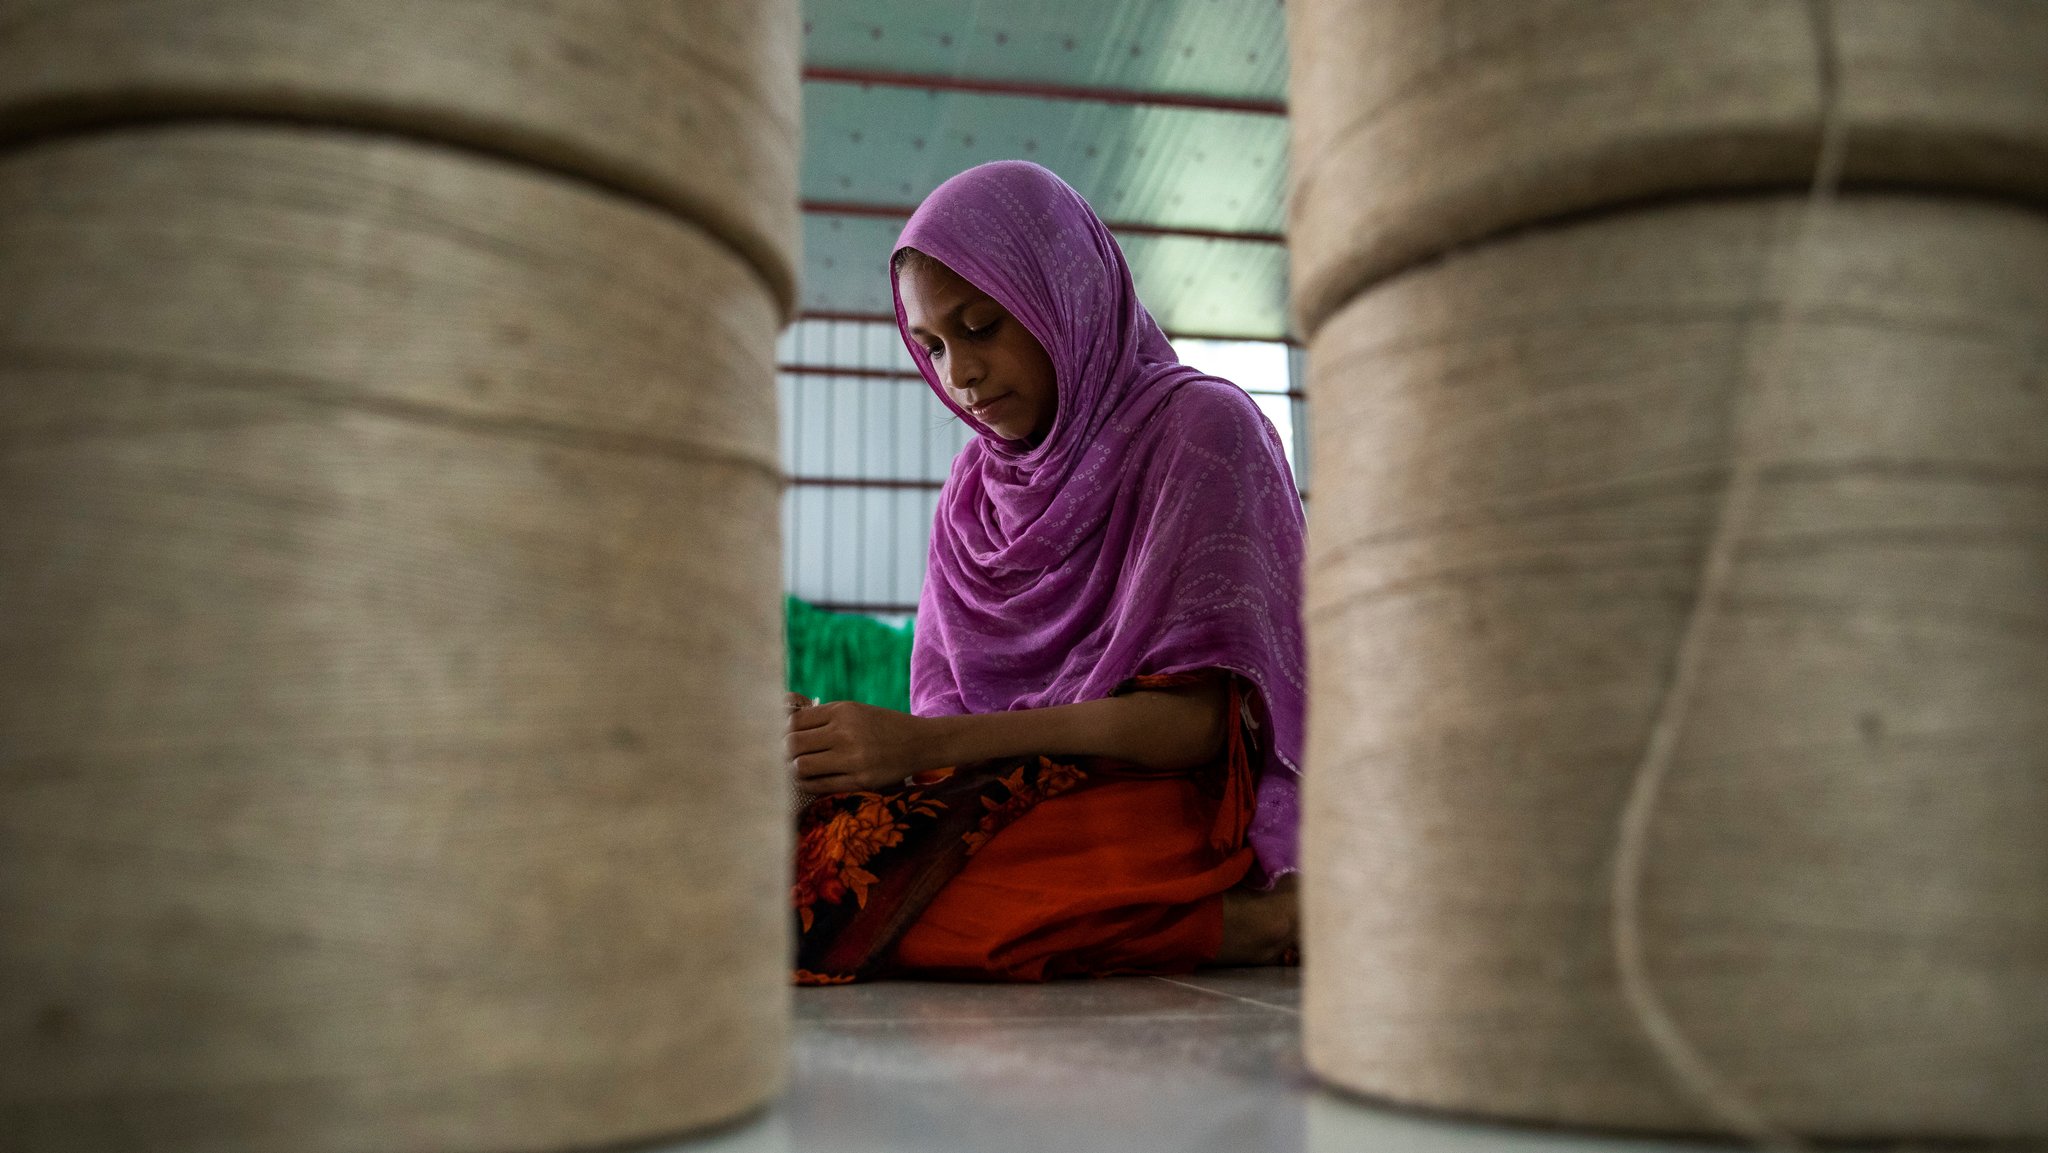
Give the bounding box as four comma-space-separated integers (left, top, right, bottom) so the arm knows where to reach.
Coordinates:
0, 0, 803, 313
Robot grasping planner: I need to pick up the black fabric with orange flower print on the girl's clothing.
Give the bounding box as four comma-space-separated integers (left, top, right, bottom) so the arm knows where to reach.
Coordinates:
791, 674, 1251, 985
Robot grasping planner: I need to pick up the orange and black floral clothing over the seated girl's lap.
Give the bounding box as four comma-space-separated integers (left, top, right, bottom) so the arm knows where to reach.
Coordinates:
791, 674, 1253, 983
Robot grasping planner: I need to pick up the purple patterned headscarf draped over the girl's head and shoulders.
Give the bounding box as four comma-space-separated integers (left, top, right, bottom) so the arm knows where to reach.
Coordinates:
895, 160, 1305, 885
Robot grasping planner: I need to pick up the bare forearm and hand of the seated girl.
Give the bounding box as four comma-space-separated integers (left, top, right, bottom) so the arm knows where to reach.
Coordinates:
788, 676, 1229, 793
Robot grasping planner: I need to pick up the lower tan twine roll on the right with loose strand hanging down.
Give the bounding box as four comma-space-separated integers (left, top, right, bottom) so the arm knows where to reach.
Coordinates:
1305, 195, 2048, 1137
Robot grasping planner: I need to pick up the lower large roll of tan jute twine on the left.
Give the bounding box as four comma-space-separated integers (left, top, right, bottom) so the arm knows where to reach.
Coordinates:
0, 126, 788, 1153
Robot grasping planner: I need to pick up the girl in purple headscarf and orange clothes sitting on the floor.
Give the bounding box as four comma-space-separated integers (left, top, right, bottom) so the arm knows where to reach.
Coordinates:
788, 162, 1303, 983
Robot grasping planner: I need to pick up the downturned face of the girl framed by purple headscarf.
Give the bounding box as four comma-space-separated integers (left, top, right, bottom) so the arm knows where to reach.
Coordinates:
897, 258, 1059, 444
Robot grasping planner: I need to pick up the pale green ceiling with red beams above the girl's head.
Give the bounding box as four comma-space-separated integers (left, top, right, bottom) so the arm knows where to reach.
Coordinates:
803, 0, 1288, 340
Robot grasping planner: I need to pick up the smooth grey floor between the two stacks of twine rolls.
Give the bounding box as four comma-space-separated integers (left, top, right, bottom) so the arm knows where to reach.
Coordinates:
674, 969, 1726, 1153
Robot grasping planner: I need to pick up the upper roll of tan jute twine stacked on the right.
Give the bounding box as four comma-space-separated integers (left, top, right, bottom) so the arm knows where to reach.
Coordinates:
1288, 0, 2048, 334
